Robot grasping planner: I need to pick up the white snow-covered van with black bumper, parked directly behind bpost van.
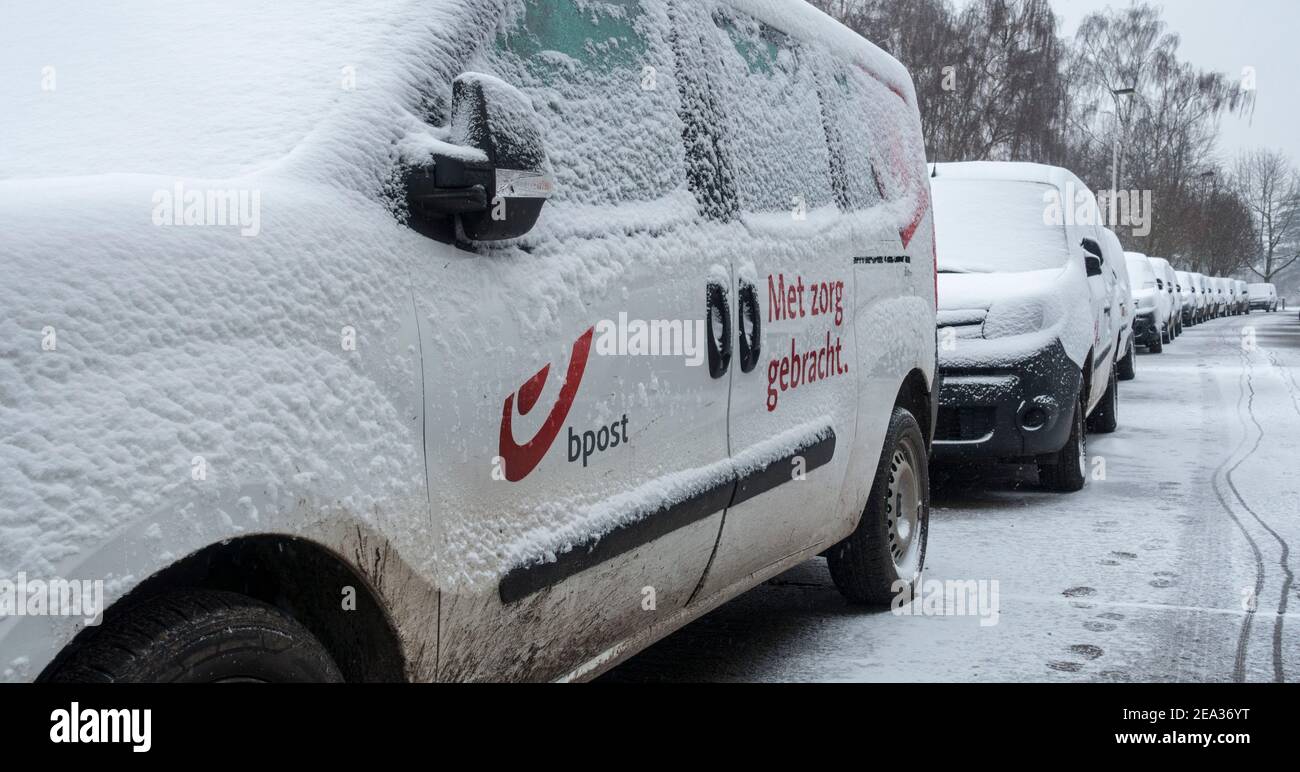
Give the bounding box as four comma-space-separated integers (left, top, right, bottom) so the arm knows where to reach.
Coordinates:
931, 162, 1121, 491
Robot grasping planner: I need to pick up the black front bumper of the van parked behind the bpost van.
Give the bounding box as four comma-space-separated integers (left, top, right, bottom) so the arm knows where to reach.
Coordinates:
933, 342, 1083, 461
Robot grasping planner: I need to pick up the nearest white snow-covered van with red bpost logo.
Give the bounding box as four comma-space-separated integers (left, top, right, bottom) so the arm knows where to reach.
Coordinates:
0, 0, 935, 681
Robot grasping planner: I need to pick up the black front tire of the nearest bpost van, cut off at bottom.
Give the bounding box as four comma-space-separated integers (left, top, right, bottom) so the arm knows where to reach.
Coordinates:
44, 590, 343, 684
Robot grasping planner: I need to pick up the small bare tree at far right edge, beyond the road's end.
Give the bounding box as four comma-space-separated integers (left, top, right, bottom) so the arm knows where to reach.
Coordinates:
1235, 151, 1300, 282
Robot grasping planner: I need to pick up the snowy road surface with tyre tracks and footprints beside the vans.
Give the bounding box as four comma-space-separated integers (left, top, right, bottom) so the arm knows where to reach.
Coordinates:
606, 312, 1300, 682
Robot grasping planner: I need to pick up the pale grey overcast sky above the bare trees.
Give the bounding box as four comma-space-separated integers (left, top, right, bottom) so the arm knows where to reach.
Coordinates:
1052, 0, 1300, 161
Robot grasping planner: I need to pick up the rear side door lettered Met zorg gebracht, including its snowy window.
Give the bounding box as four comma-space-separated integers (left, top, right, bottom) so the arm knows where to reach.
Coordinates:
680, 0, 863, 598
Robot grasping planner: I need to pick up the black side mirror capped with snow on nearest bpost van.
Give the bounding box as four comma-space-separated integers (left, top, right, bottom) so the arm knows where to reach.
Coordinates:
406, 73, 555, 242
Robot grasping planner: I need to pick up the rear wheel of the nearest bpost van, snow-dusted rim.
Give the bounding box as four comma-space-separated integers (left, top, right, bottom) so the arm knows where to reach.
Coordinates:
827, 408, 930, 606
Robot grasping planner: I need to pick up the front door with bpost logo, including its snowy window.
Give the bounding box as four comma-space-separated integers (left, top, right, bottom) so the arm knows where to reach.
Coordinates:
416, 0, 735, 681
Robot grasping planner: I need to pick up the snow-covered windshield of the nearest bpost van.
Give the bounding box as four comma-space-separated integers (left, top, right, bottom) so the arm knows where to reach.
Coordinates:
0, 0, 410, 179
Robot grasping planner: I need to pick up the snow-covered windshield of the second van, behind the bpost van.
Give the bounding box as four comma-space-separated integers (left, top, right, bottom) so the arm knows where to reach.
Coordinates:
931, 178, 1070, 273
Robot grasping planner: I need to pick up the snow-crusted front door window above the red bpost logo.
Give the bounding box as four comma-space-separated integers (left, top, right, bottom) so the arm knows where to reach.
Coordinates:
477, 0, 686, 205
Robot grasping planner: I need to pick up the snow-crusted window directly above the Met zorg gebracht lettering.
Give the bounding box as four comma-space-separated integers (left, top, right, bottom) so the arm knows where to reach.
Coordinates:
714, 9, 836, 212
